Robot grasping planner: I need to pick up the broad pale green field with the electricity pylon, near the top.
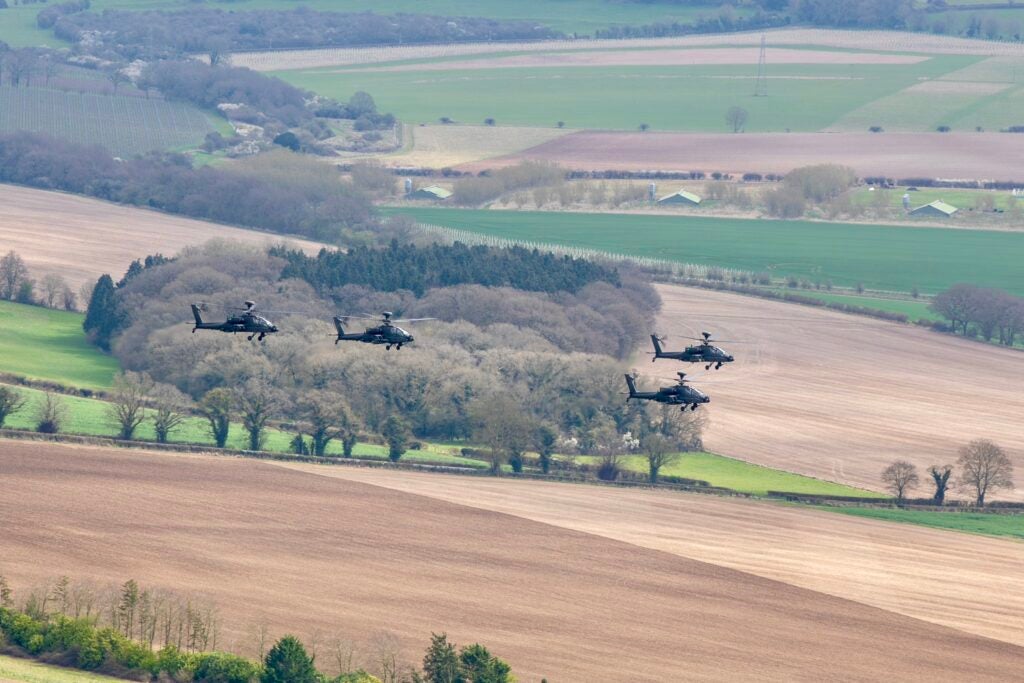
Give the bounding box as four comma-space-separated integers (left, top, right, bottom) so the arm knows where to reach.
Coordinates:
276, 55, 983, 132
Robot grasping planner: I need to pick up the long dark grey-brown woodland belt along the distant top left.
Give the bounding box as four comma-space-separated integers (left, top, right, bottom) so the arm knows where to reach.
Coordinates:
44, 7, 562, 61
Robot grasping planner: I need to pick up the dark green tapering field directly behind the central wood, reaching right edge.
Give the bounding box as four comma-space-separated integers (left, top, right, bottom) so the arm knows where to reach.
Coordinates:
391, 208, 1024, 295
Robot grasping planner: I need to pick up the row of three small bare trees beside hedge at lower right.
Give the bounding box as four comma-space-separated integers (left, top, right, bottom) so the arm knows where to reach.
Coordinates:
882, 439, 1014, 508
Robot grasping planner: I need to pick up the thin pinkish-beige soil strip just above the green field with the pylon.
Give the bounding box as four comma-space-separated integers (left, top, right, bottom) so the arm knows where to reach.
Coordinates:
354, 47, 927, 72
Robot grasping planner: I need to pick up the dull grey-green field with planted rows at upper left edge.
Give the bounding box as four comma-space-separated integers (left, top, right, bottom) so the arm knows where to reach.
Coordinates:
0, 85, 218, 156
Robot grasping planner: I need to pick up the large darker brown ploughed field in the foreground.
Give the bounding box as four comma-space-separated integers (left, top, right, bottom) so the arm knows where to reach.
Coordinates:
6, 442, 1024, 681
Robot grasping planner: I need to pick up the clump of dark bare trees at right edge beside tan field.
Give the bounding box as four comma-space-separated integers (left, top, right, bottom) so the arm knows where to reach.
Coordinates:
929, 283, 1024, 346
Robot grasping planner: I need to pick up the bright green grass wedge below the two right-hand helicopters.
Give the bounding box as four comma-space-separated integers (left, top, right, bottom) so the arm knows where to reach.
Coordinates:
578, 453, 886, 498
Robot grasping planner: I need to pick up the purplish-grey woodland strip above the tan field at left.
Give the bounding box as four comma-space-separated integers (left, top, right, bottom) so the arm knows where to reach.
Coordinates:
0, 132, 376, 243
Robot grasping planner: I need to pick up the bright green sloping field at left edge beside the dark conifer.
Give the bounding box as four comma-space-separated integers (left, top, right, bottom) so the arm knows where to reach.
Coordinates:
0, 301, 119, 389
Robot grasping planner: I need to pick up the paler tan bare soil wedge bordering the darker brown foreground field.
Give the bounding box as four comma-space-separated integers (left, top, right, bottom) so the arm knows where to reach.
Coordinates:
285, 464, 1024, 645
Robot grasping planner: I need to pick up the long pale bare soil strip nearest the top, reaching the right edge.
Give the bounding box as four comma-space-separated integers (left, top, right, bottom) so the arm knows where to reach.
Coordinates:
230, 29, 1024, 71
